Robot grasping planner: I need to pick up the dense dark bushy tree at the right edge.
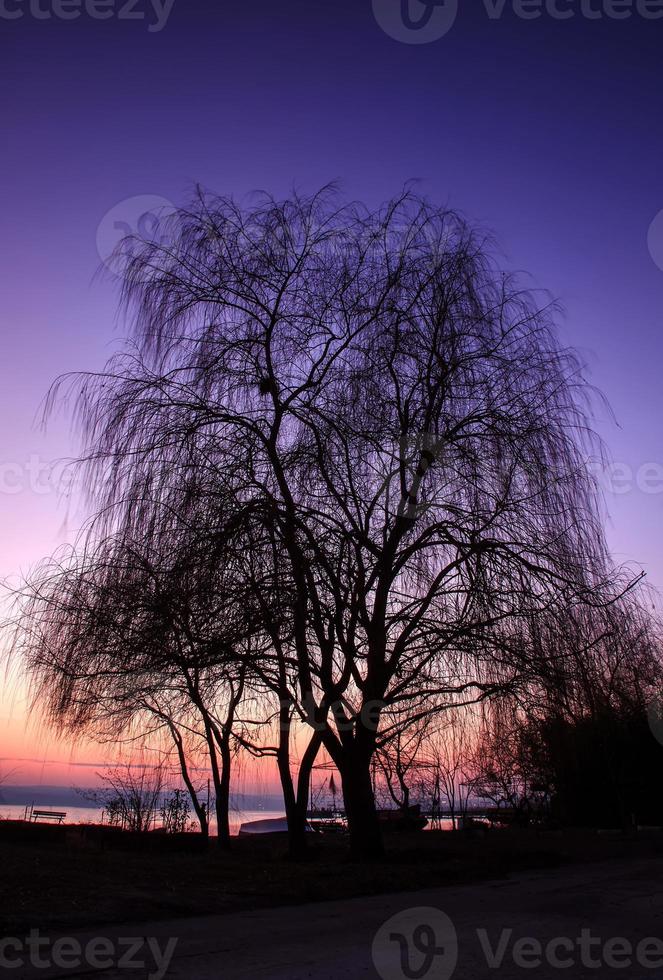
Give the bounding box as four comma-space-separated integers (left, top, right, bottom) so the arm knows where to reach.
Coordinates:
475, 596, 663, 827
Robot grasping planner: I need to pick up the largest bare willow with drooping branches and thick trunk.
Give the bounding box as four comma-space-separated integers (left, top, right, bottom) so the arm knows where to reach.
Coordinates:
37, 188, 628, 858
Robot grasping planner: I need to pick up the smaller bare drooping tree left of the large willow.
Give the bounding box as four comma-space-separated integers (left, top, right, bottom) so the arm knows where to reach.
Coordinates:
16, 506, 260, 843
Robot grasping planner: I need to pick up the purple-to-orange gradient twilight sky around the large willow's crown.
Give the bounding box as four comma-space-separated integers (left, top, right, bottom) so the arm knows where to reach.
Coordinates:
0, 0, 663, 781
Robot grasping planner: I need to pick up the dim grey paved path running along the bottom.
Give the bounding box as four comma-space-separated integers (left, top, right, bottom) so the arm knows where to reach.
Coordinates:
11, 860, 663, 980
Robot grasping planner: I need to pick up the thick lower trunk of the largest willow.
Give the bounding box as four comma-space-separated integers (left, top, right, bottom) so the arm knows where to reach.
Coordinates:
340, 752, 384, 861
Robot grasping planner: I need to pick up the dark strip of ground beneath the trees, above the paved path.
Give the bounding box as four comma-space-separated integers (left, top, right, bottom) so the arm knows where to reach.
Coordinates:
0, 822, 663, 935
